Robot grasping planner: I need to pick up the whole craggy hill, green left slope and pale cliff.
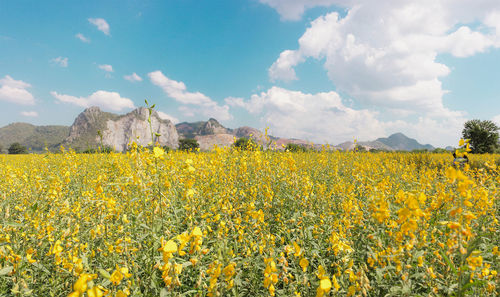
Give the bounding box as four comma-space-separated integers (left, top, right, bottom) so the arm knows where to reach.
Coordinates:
64, 107, 179, 151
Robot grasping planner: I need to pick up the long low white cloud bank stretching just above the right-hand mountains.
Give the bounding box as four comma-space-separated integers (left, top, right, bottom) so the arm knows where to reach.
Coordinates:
232, 86, 466, 146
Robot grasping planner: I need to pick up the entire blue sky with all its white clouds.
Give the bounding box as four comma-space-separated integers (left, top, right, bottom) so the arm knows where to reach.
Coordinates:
0, 0, 500, 146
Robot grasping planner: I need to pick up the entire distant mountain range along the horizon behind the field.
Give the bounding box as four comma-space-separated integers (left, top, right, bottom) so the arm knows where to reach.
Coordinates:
0, 107, 442, 151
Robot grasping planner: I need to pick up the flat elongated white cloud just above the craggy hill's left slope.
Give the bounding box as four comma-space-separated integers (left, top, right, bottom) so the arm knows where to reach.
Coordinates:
50, 90, 135, 111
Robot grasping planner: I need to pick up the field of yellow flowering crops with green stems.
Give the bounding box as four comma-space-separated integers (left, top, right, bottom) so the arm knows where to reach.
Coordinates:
0, 148, 500, 297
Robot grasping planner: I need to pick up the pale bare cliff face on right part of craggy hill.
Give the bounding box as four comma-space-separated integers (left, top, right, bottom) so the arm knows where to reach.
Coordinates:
102, 107, 179, 151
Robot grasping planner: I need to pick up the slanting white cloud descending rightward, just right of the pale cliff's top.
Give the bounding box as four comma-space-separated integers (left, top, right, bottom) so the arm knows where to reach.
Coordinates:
148, 71, 232, 121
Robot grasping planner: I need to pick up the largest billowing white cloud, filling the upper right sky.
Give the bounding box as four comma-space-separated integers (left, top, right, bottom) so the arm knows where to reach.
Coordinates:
270, 0, 500, 116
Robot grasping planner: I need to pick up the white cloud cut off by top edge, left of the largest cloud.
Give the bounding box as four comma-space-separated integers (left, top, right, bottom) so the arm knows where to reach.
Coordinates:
260, 0, 338, 21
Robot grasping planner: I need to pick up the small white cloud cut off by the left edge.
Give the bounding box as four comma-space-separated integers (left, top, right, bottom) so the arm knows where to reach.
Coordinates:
0, 75, 35, 105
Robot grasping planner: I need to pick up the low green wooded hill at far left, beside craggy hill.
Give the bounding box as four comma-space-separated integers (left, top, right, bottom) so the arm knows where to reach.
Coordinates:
0, 123, 69, 151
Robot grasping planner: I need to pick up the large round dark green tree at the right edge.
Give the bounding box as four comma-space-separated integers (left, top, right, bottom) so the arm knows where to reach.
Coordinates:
462, 120, 500, 154
